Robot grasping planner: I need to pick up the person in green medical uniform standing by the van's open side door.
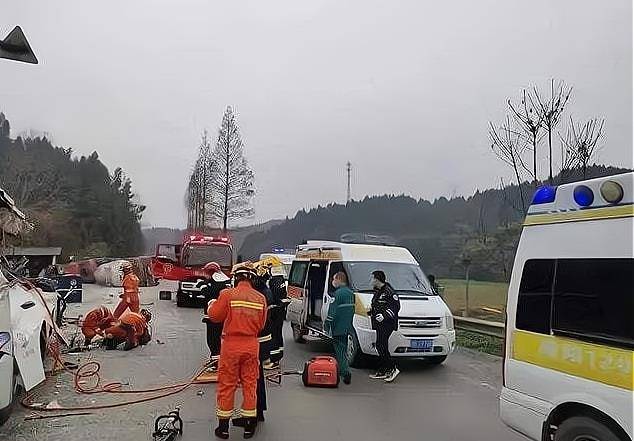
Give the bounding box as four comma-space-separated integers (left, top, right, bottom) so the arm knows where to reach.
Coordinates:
324, 272, 354, 384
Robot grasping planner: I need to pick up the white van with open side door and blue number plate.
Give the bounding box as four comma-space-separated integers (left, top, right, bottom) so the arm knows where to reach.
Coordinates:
286, 241, 456, 365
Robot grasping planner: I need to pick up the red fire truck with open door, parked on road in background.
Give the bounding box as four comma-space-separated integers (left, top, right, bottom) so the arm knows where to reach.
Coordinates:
152, 234, 234, 306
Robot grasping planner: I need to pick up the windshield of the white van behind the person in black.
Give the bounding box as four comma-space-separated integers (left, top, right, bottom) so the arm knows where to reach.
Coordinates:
344, 262, 436, 296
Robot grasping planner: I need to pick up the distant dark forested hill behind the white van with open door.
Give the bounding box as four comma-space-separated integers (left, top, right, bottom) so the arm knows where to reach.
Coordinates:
240, 166, 627, 280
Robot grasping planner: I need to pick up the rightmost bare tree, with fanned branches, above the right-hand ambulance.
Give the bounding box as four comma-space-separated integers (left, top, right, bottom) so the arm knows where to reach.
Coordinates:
563, 117, 605, 179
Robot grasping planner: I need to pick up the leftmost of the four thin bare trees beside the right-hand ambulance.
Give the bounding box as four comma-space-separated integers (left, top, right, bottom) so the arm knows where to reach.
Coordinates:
489, 116, 526, 211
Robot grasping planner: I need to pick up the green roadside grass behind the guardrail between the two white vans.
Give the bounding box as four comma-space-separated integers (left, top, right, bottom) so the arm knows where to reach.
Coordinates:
438, 279, 508, 322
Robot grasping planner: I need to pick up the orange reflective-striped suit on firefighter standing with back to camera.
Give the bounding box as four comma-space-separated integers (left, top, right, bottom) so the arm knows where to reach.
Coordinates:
207, 281, 266, 419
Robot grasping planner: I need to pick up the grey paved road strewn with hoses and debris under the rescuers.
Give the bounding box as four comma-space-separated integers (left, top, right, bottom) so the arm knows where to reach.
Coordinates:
0, 286, 524, 441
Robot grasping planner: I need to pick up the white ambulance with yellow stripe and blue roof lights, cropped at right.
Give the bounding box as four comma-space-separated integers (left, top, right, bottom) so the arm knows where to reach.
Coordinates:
500, 173, 634, 441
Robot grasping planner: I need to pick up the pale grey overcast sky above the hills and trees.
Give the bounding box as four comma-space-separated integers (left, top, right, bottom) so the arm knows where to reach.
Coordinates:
0, 0, 632, 226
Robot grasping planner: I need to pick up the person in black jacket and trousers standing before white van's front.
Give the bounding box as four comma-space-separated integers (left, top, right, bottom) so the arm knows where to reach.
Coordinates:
369, 271, 401, 383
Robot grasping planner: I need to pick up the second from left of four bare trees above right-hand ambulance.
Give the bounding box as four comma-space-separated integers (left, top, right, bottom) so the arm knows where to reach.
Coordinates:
507, 89, 543, 187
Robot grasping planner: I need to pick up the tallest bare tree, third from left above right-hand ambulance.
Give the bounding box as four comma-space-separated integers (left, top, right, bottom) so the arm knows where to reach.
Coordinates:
530, 79, 572, 185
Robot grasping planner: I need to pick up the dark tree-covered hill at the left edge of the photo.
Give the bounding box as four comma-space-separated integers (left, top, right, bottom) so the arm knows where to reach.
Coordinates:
0, 113, 145, 257
